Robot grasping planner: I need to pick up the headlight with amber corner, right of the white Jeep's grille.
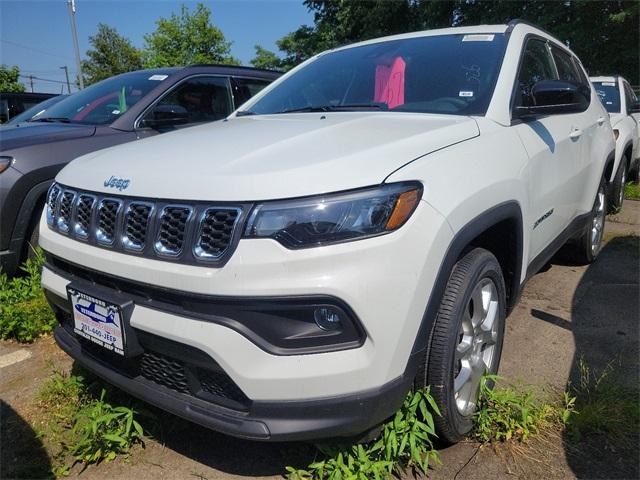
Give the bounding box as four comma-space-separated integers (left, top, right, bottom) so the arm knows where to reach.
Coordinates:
244, 182, 422, 248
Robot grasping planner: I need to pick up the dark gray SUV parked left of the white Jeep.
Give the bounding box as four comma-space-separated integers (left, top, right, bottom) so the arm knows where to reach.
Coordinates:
0, 65, 280, 275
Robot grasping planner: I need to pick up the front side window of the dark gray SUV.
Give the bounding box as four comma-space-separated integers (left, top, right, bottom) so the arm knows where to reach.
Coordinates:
150, 77, 233, 124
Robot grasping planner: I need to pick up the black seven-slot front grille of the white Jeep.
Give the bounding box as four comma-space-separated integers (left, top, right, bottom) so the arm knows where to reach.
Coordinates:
46, 184, 245, 266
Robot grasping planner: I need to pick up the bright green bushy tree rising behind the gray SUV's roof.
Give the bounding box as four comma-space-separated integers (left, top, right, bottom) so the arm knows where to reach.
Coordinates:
144, 3, 240, 68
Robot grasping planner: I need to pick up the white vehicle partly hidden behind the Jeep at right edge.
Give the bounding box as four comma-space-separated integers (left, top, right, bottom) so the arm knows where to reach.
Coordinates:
590, 75, 640, 211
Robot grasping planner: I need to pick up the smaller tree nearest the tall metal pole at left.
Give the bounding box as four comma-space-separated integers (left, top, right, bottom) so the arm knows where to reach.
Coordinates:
82, 23, 142, 85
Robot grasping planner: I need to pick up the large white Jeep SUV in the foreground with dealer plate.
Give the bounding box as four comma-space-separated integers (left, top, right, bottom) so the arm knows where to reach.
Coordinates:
40, 22, 614, 442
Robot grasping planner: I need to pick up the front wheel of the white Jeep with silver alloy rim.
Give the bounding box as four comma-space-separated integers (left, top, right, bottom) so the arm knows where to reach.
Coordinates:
416, 248, 506, 443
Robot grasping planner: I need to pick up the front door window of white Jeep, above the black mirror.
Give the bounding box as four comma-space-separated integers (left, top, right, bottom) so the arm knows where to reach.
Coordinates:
515, 39, 557, 107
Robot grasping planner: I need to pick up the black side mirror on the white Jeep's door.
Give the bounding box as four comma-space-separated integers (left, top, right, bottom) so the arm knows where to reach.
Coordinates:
515, 80, 589, 118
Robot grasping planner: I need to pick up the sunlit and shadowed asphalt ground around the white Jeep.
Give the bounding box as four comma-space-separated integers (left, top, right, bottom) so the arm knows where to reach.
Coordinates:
0, 201, 640, 480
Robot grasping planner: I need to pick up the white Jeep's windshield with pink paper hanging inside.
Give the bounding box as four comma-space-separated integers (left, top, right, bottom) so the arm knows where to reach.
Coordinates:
248, 33, 506, 115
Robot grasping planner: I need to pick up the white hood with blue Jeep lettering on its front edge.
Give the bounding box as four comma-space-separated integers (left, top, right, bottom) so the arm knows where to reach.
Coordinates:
57, 112, 479, 201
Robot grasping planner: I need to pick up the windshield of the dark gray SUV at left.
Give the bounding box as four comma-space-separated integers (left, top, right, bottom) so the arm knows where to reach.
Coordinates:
34, 72, 168, 125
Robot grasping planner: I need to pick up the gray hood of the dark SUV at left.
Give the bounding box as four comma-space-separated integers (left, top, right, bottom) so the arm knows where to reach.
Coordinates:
0, 123, 96, 152
